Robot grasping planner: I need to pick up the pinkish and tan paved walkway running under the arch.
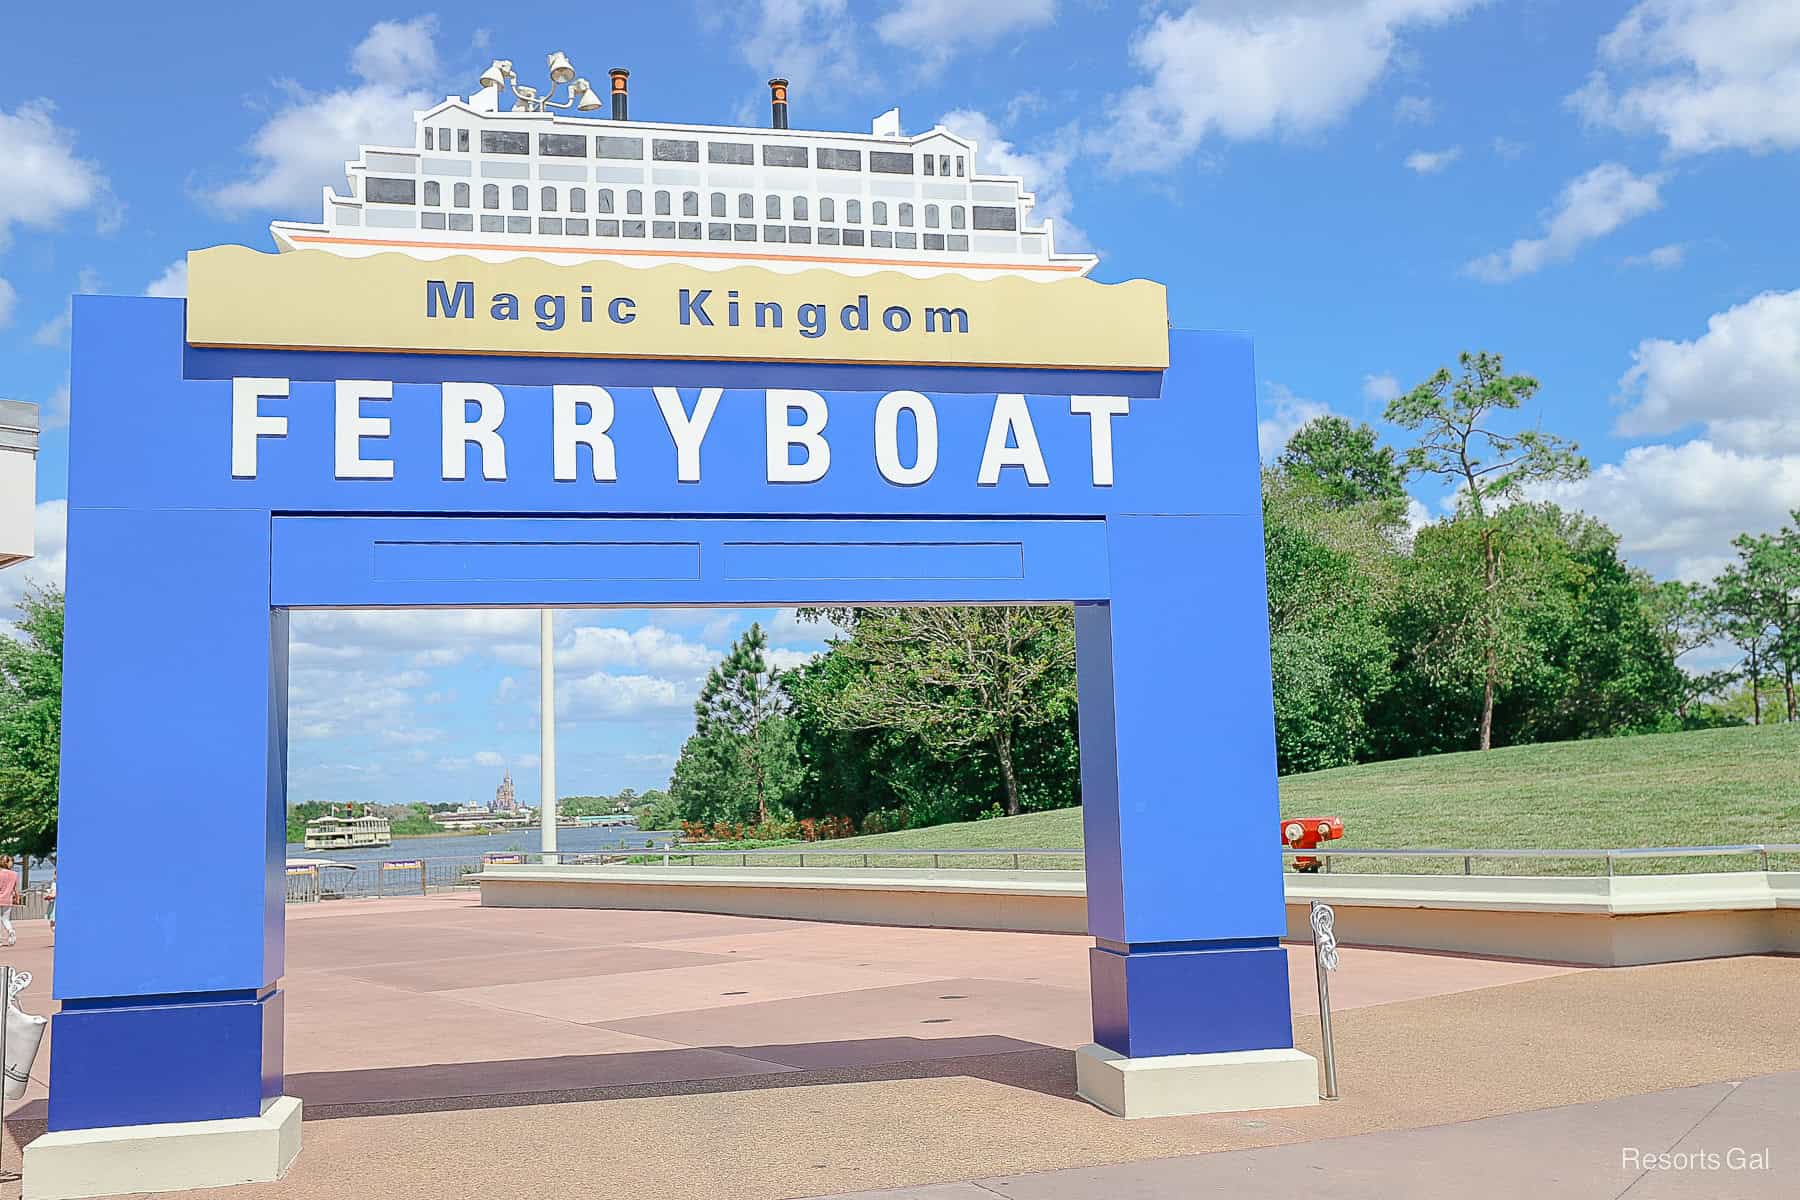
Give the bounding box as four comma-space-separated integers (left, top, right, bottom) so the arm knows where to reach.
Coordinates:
0, 896, 1800, 1200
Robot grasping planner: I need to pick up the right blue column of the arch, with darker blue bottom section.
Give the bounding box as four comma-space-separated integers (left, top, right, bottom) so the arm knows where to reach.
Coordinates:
1075, 516, 1294, 1058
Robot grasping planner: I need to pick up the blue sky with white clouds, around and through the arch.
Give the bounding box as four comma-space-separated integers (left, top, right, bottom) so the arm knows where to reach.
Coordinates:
0, 0, 1800, 801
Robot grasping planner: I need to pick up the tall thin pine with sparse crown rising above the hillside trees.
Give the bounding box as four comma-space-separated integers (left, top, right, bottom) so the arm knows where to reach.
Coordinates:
1386, 351, 1588, 750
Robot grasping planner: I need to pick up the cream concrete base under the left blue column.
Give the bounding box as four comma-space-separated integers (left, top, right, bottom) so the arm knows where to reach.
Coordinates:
23, 1096, 301, 1200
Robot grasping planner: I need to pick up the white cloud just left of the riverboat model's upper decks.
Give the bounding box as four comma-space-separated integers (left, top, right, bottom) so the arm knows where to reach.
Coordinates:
205, 16, 439, 216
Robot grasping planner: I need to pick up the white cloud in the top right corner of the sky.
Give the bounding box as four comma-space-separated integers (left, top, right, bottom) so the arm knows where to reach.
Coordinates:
1570, 0, 1800, 155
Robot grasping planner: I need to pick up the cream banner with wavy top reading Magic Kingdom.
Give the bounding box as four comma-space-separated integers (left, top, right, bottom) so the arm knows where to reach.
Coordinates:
187, 246, 1168, 371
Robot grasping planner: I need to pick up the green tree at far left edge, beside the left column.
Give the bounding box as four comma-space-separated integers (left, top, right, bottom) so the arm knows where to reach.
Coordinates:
0, 588, 63, 874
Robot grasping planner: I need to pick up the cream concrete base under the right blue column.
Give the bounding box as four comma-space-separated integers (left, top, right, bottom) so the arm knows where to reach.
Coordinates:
1075, 1045, 1319, 1117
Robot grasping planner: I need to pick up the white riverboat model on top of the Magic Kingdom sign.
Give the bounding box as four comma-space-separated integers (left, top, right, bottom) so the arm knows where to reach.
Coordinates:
270, 54, 1098, 279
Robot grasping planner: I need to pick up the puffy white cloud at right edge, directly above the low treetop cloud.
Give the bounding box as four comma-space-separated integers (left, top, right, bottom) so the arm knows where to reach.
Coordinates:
1618, 290, 1800, 453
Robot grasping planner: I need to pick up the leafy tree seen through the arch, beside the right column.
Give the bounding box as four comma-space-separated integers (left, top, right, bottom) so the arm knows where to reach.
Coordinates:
810, 604, 1075, 815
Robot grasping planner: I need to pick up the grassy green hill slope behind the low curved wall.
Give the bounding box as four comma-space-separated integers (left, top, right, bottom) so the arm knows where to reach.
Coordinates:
781, 725, 1800, 874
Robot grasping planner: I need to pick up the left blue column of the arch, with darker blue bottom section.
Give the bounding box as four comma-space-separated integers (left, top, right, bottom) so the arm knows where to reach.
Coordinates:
50, 507, 288, 1130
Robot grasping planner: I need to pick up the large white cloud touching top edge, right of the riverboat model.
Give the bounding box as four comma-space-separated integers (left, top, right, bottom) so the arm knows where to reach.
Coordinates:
1100, 0, 1480, 171
